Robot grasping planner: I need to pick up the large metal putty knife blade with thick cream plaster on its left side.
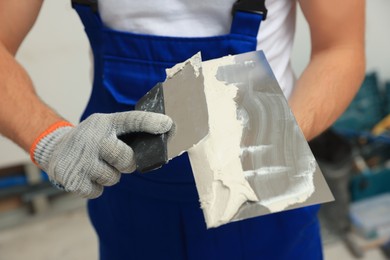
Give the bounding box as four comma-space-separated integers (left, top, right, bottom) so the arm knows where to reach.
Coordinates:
189, 51, 333, 227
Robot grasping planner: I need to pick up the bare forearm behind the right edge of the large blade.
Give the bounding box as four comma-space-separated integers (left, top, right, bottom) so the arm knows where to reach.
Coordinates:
289, 45, 365, 140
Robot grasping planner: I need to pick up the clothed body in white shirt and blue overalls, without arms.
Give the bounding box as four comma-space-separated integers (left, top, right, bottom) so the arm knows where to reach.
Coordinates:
74, 3, 321, 259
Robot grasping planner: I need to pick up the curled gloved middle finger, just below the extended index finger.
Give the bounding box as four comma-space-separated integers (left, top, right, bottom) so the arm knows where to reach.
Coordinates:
100, 136, 136, 173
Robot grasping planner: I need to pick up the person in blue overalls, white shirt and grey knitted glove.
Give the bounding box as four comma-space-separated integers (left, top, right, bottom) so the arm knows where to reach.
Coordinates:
0, 0, 365, 260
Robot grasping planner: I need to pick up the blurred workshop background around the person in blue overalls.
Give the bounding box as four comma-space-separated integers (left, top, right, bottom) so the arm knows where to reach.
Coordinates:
0, 0, 390, 260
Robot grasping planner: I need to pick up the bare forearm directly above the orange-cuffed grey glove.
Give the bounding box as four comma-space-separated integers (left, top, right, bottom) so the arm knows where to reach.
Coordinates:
0, 43, 61, 151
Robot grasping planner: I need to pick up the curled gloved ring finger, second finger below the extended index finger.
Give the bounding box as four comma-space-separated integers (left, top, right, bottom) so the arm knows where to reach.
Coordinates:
91, 162, 121, 186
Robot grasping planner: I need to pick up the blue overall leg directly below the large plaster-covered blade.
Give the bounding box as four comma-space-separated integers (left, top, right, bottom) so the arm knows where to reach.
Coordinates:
184, 203, 322, 260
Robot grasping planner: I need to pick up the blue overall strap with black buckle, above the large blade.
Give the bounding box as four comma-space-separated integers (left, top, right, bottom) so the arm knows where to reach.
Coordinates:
230, 0, 268, 38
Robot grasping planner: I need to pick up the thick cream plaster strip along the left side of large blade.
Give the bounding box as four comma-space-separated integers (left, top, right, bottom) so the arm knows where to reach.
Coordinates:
188, 57, 258, 228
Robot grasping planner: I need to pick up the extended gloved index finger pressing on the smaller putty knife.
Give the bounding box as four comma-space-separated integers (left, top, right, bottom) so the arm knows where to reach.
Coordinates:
115, 111, 173, 135
